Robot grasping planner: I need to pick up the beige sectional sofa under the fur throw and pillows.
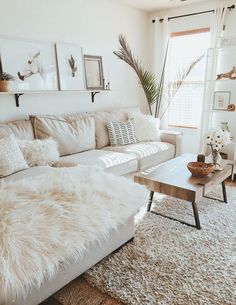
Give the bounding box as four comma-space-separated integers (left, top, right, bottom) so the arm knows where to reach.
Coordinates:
0, 109, 182, 305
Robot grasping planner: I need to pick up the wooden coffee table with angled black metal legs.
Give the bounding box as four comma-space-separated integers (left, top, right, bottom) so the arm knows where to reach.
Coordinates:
134, 154, 233, 230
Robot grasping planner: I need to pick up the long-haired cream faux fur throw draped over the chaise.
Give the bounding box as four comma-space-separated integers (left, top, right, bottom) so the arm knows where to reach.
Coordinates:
0, 165, 147, 304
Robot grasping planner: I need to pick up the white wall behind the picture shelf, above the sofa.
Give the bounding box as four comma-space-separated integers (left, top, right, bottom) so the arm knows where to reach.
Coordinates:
0, 0, 148, 121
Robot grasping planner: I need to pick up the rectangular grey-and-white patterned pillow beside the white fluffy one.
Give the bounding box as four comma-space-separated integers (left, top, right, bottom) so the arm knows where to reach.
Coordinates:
106, 120, 138, 146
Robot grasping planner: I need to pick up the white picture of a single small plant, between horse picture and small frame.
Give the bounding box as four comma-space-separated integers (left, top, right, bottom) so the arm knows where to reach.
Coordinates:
56, 42, 85, 90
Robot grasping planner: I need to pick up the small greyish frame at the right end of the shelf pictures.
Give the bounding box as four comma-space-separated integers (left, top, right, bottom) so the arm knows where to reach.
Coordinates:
84, 55, 104, 90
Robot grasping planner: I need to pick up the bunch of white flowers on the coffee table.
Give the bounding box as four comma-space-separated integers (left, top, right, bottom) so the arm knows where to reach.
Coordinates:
206, 129, 231, 152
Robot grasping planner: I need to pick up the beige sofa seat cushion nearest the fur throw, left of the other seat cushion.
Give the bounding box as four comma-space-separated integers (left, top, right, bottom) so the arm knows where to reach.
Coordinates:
56, 149, 138, 175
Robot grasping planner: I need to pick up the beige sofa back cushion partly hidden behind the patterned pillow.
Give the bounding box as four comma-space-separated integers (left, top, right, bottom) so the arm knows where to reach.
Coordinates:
94, 111, 128, 148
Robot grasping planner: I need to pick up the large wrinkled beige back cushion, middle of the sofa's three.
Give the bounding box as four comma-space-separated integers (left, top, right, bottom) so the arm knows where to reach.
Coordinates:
30, 115, 95, 156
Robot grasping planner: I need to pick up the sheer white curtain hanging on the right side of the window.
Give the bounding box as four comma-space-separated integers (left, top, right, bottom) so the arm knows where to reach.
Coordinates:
200, 1, 227, 153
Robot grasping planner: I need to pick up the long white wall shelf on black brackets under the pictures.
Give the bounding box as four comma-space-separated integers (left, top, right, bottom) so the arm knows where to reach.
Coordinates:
0, 90, 111, 107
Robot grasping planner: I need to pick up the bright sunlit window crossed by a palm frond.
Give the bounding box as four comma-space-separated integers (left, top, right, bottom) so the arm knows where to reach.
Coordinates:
168, 28, 210, 128
